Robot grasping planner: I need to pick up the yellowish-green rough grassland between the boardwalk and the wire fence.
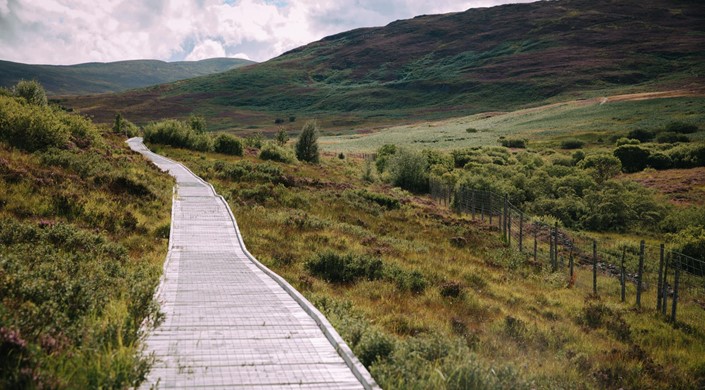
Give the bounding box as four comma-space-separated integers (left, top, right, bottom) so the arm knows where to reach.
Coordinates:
159, 147, 705, 388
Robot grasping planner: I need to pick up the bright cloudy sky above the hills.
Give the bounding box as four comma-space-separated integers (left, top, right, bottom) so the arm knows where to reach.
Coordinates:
0, 0, 532, 65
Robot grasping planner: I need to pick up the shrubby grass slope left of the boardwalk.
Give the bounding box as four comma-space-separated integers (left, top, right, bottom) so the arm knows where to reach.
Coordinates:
0, 91, 172, 389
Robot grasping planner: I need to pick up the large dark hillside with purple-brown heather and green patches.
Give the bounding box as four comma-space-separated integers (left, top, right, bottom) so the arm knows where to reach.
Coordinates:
65, 0, 705, 128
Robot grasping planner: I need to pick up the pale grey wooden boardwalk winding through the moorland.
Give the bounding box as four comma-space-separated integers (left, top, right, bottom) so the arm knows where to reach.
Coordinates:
128, 138, 377, 389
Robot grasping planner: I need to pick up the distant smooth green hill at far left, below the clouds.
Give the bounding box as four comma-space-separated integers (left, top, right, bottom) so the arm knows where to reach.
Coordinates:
0, 58, 253, 95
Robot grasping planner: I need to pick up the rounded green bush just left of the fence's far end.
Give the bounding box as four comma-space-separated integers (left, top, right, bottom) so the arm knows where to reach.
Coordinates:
387, 149, 428, 193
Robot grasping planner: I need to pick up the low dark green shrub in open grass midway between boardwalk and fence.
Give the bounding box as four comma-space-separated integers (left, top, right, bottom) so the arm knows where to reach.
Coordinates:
304, 251, 383, 283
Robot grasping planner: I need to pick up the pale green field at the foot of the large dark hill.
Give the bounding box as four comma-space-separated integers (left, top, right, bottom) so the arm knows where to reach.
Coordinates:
320, 96, 705, 153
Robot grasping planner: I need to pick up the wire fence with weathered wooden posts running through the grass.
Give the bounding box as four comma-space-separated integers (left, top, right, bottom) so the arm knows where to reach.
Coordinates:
430, 180, 705, 328
